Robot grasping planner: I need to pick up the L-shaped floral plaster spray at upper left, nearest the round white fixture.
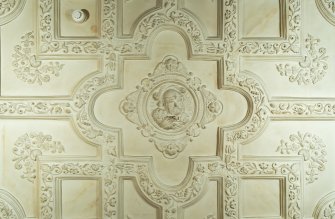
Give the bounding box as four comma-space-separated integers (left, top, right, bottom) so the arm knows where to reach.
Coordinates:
12, 32, 64, 85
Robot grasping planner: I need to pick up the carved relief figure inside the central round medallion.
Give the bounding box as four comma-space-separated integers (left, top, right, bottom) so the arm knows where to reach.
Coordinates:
152, 86, 191, 130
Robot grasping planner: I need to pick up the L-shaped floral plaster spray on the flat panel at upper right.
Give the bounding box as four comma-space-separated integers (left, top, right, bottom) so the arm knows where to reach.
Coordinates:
277, 35, 328, 85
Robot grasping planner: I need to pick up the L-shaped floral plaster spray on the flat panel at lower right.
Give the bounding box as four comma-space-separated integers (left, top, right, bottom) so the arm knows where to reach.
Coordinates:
277, 132, 327, 183
